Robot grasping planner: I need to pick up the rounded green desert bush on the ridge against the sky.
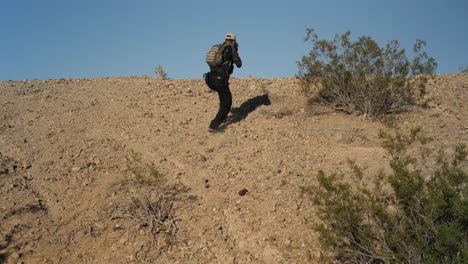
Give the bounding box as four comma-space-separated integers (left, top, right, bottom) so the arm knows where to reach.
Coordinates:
298, 29, 437, 118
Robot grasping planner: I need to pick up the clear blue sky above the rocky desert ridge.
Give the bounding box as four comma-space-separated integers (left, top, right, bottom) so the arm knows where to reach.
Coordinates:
0, 0, 468, 80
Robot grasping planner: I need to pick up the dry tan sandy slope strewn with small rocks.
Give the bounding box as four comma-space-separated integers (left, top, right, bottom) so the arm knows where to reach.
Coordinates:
0, 74, 468, 263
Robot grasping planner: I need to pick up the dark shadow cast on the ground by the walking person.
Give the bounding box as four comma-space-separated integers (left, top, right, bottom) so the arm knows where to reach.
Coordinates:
220, 94, 271, 129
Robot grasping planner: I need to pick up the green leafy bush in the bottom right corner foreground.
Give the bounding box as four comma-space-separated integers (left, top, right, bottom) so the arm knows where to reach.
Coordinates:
302, 128, 468, 263
